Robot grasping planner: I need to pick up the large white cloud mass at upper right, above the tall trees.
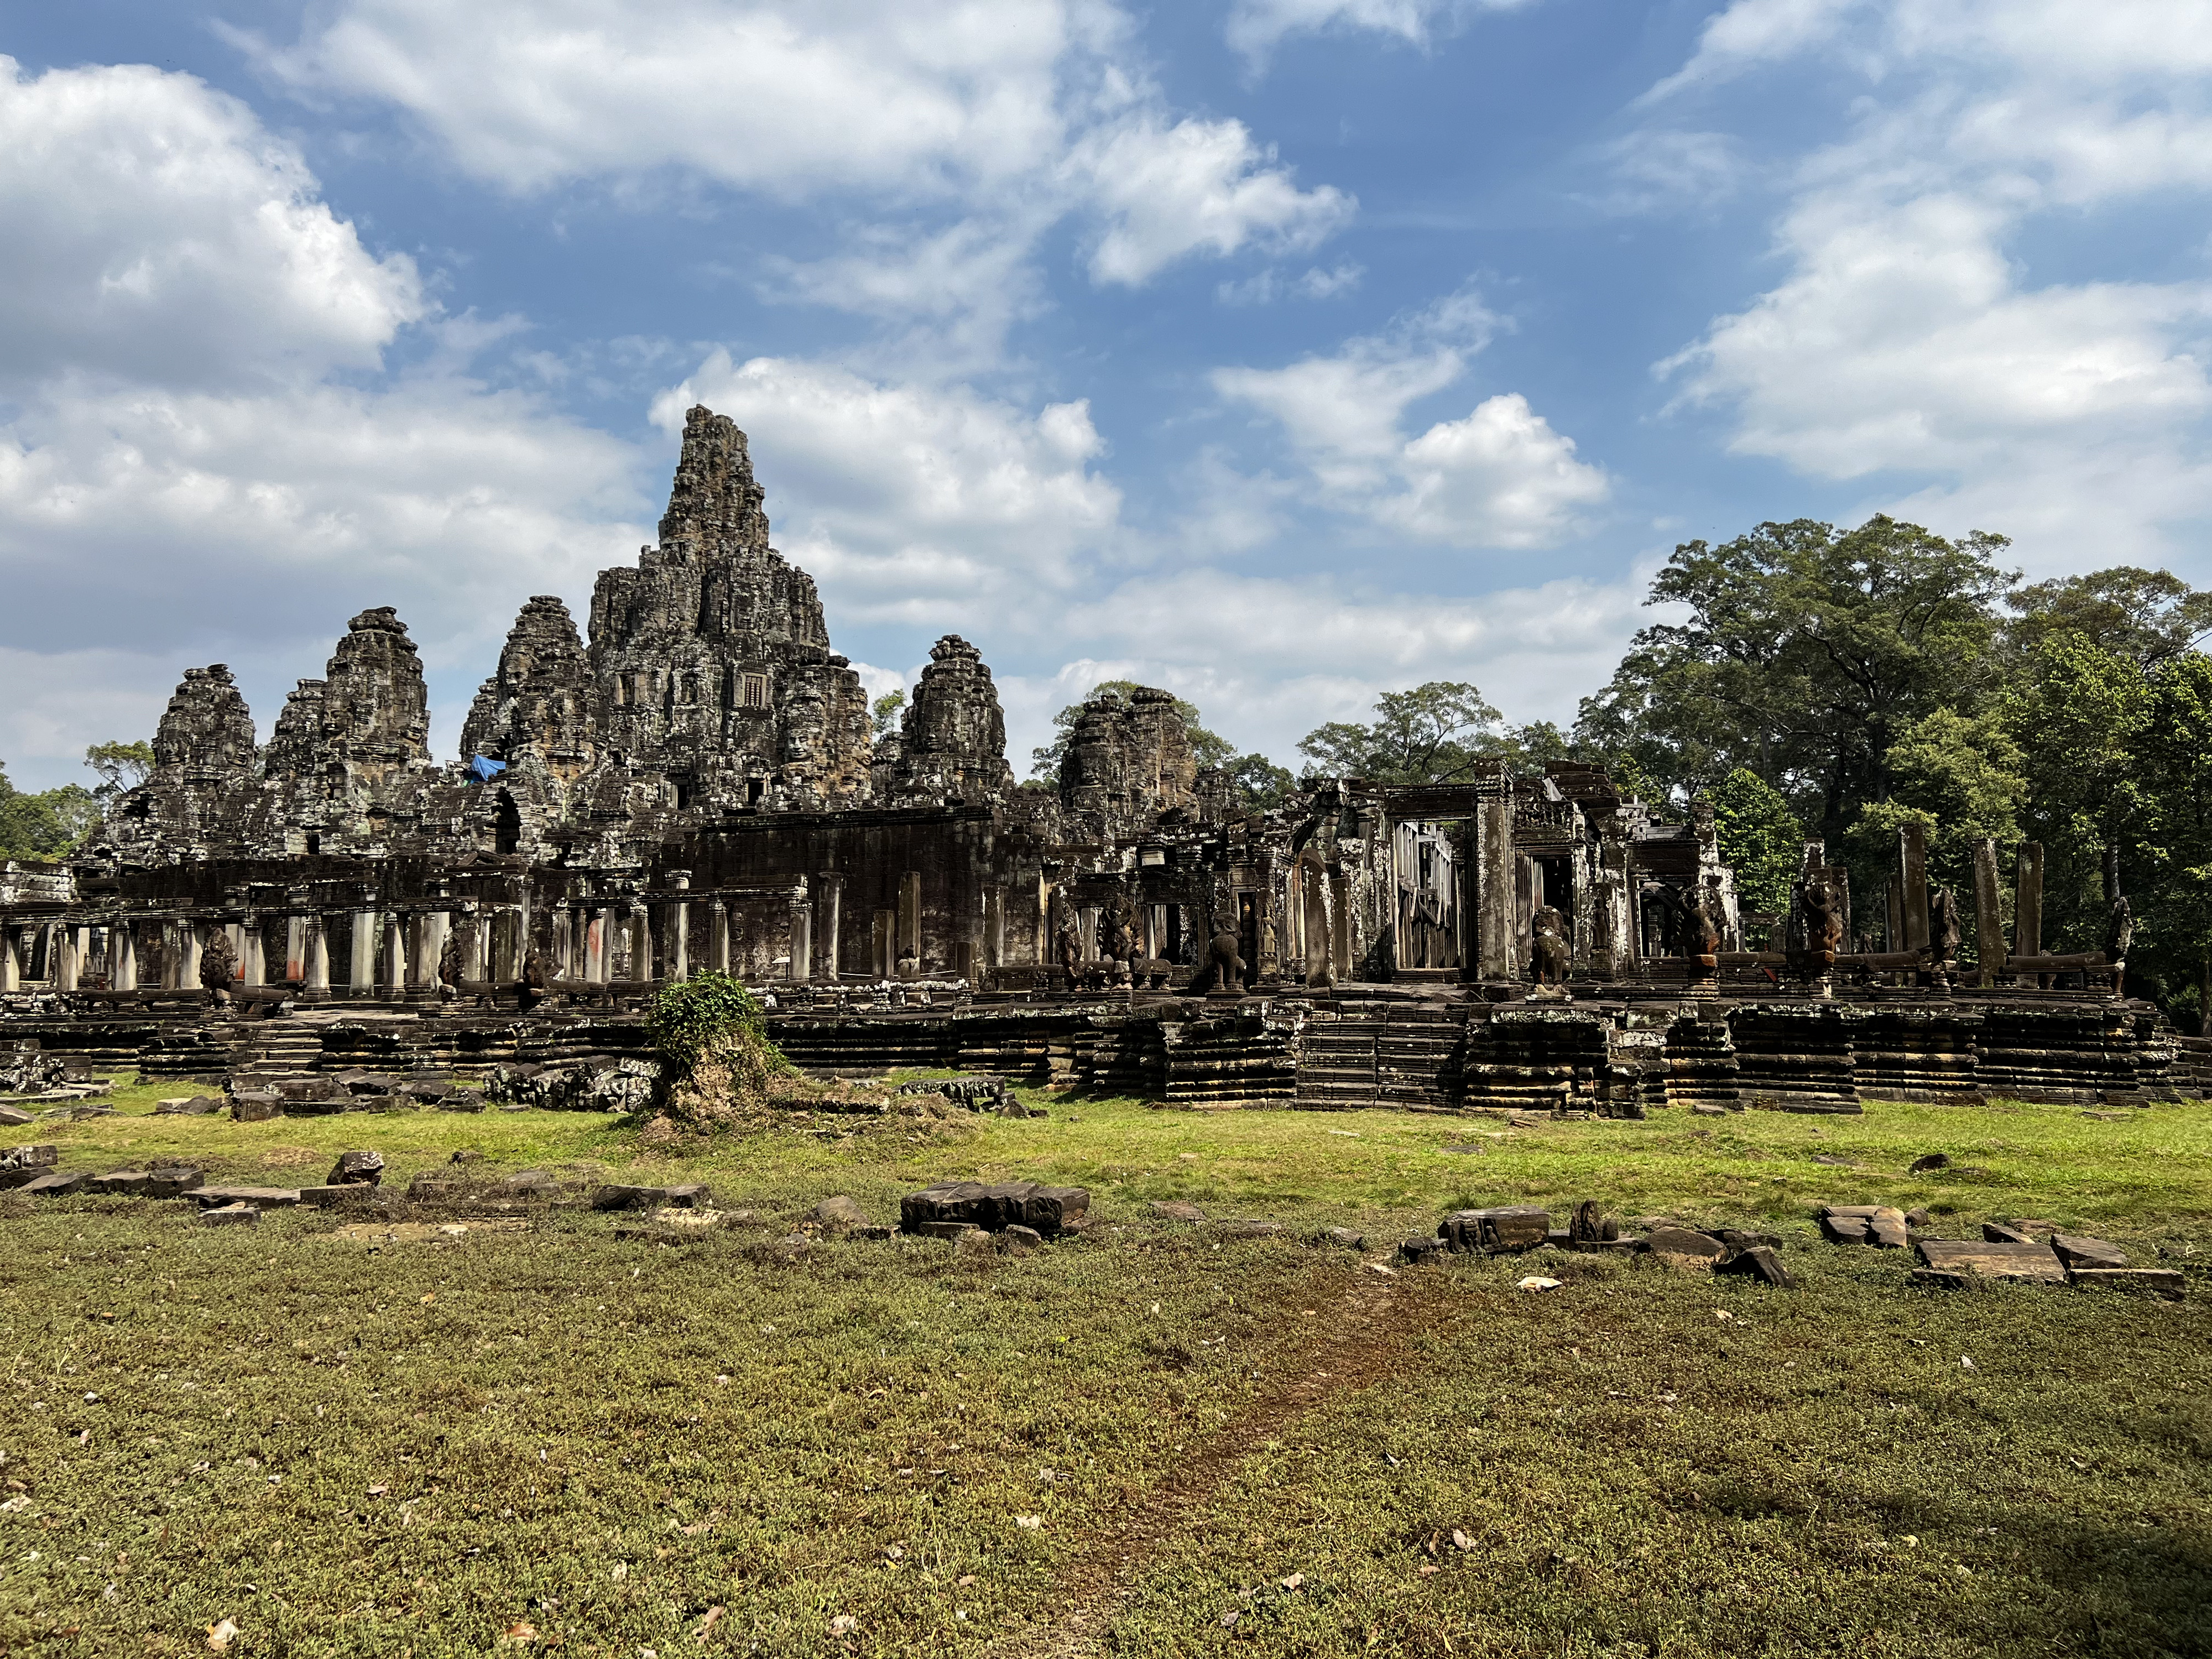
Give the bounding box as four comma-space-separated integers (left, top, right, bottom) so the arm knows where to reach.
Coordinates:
1659, 0, 2212, 566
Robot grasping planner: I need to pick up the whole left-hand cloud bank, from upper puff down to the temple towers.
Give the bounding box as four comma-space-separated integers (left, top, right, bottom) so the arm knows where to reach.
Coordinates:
0, 64, 639, 783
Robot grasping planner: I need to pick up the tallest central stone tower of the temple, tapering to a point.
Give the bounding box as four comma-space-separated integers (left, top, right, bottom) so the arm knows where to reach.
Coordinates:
591, 407, 869, 810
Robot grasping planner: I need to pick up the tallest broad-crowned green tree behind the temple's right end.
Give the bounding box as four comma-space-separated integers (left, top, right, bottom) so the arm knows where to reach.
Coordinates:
1575, 515, 2015, 841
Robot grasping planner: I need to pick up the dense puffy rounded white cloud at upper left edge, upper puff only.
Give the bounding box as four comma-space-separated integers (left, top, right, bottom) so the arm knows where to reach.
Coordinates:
0, 58, 425, 385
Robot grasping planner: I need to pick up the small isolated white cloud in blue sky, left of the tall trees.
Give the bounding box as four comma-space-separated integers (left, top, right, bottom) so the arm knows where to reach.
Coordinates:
1212, 294, 1610, 546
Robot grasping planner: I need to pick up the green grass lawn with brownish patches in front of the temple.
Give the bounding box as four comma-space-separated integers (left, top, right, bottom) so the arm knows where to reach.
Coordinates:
0, 1088, 2212, 1659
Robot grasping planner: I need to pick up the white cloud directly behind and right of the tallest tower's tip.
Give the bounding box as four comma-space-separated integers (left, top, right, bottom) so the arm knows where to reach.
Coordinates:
653, 352, 1121, 626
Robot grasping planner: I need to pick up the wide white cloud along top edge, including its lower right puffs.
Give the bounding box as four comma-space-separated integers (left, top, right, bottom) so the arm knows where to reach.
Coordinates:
248, 0, 1354, 341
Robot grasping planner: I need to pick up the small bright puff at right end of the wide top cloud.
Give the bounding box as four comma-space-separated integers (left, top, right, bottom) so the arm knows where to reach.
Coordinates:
1071, 115, 1354, 288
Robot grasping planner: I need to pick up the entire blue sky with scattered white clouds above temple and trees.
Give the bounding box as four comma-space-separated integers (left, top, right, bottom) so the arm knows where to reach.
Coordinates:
0, 0, 2212, 785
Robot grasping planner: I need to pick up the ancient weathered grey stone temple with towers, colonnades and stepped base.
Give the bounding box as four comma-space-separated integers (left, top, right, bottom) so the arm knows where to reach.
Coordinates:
0, 409, 2203, 1115
